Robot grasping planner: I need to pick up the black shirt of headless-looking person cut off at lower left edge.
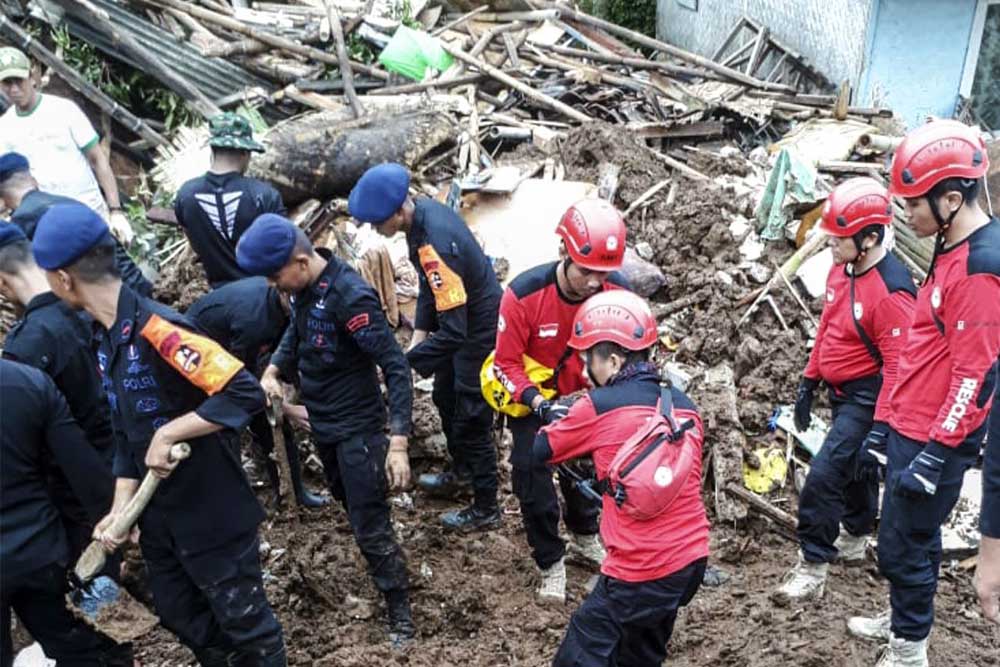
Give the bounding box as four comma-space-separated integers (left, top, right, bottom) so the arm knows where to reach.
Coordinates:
0, 359, 114, 585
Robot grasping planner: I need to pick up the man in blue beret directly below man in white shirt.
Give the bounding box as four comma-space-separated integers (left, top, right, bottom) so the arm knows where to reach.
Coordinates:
0, 153, 153, 296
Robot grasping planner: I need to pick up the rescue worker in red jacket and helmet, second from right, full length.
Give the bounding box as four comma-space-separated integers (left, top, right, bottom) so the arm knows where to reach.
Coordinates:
777, 178, 917, 600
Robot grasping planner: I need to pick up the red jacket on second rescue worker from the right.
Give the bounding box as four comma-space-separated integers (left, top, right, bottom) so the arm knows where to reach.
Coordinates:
804, 253, 917, 421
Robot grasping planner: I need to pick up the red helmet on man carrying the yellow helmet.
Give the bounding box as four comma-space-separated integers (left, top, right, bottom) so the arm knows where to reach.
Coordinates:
556, 199, 625, 271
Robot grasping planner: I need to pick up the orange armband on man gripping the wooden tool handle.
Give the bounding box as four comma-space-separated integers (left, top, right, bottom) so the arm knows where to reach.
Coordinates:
141, 315, 243, 396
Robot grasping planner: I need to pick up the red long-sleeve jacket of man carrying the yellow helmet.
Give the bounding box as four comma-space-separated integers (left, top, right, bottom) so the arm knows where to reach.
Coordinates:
494, 262, 628, 406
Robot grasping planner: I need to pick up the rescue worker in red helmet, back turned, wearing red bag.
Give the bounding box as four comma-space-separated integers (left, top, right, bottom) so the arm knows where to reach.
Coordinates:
534, 290, 709, 667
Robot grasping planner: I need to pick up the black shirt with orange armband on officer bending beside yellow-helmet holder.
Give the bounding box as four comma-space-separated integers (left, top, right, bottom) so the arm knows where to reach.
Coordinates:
406, 198, 503, 392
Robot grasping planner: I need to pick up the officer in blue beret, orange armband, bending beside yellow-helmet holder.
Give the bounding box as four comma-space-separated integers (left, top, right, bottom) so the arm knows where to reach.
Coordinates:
348, 163, 503, 531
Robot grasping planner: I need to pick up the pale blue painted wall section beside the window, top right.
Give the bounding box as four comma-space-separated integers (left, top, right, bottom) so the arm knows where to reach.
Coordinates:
855, 0, 976, 128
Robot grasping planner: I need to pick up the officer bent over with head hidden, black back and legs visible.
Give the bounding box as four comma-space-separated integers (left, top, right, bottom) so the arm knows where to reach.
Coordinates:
185, 277, 329, 507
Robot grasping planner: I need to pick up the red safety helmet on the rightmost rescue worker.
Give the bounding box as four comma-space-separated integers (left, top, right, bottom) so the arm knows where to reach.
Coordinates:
892, 120, 990, 198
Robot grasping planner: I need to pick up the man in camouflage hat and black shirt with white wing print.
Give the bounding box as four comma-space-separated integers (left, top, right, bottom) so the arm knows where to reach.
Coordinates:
174, 112, 285, 287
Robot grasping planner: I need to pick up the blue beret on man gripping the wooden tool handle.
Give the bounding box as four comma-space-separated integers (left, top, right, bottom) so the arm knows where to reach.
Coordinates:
31, 203, 113, 271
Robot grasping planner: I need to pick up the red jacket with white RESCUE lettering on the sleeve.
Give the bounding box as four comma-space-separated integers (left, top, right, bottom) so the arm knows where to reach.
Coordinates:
889, 218, 1000, 447
